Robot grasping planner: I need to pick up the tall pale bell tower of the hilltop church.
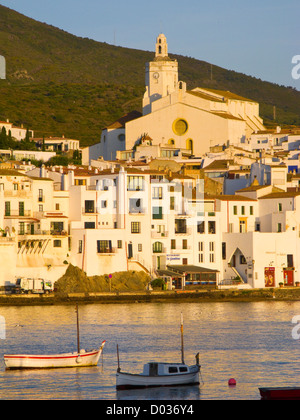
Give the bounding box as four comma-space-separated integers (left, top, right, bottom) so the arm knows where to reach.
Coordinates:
143, 34, 178, 115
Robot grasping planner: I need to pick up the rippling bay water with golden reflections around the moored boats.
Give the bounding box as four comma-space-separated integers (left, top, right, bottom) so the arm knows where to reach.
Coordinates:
0, 301, 300, 400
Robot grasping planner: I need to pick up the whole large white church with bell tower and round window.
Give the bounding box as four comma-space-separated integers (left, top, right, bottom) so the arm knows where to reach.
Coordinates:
84, 34, 265, 160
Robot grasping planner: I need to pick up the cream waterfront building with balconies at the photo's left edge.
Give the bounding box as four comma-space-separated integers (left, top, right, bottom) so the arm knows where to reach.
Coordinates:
0, 169, 69, 285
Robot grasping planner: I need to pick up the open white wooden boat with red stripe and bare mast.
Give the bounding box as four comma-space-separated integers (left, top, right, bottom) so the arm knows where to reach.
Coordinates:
4, 306, 106, 369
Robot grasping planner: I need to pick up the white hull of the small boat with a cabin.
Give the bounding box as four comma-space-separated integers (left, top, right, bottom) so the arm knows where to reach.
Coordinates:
116, 367, 200, 390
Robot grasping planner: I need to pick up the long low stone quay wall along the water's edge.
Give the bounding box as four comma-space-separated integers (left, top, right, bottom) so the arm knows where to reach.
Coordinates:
0, 287, 300, 306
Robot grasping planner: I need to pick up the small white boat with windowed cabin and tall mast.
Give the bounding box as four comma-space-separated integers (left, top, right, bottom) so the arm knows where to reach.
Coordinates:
116, 317, 201, 390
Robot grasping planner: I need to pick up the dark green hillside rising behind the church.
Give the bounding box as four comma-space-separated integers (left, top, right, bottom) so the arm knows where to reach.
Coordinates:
0, 5, 300, 146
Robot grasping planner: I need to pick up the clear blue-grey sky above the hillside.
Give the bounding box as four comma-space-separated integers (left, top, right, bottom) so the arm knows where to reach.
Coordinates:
0, 0, 300, 90
